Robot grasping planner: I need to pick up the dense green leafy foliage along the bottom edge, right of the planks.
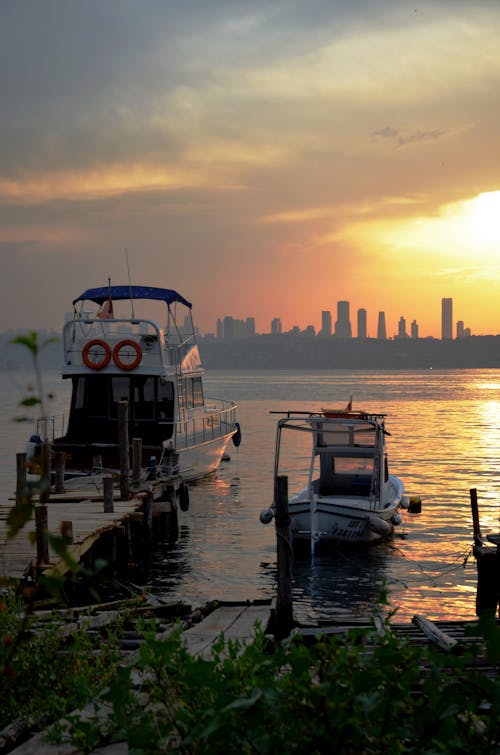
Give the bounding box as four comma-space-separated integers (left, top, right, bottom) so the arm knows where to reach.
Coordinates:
49, 620, 500, 755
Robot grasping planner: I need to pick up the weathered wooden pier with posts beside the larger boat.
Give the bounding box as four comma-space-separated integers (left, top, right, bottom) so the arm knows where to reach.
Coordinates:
0, 481, 178, 584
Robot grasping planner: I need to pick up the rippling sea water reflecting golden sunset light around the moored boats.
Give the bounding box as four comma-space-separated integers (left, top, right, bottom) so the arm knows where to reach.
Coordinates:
0, 370, 500, 622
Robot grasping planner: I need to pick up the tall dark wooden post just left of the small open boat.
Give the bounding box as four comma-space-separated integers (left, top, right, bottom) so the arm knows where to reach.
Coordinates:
274, 475, 293, 640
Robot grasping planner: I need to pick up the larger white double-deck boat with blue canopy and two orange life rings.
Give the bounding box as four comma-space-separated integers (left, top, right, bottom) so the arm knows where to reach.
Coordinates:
39, 285, 241, 481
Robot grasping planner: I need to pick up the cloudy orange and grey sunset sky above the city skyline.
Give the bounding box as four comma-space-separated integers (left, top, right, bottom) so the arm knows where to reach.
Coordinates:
0, 0, 500, 337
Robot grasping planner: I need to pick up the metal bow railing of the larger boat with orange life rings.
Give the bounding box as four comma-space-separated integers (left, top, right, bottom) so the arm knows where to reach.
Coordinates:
175, 399, 237, 449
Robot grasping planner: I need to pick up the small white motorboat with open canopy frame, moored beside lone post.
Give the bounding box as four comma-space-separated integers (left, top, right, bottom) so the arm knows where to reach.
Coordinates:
261, 409, 408, 551
